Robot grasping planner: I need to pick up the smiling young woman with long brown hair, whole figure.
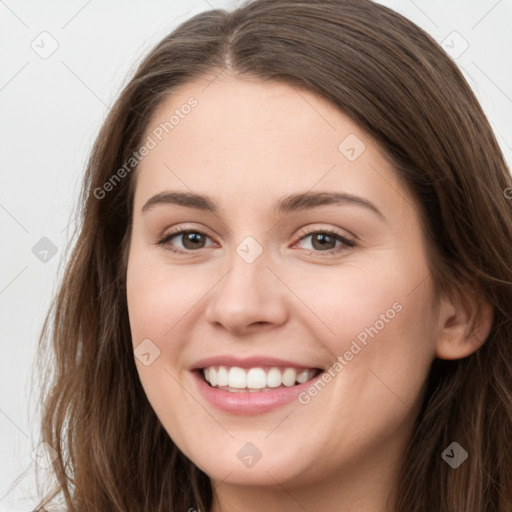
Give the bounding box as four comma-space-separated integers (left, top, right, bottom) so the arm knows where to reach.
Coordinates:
34, 0, 512, 512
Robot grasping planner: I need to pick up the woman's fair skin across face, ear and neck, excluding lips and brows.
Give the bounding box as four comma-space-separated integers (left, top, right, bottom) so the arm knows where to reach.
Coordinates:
127, 73, 492, 512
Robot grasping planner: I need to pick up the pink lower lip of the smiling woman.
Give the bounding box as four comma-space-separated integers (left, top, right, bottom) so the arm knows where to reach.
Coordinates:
192, 371, 323, 415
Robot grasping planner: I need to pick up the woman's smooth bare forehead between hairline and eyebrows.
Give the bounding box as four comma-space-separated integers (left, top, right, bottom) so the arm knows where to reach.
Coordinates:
136, 75, 405, 218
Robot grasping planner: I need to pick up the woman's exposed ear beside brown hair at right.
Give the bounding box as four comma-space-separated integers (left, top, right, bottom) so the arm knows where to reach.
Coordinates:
436, 293, 494, 359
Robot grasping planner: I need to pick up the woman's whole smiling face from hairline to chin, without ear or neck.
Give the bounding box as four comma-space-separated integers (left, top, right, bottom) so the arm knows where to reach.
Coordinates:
127, 75, 436, 489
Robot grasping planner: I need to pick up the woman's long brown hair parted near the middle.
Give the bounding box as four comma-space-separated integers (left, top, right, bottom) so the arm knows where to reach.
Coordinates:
32, 0, 512, 512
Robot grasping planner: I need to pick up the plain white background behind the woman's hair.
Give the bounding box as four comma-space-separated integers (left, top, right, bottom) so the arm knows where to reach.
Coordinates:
0, 0, 512, 512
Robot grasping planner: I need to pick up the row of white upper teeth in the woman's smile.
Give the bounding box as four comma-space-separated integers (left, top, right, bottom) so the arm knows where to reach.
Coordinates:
203, 366, 316, 389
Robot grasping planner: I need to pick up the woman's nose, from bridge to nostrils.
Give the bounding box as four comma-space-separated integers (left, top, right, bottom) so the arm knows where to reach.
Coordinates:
205, 247, 289, 335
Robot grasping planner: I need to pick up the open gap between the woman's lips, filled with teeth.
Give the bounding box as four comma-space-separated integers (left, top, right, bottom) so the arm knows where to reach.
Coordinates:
196, 365, 323, 393
